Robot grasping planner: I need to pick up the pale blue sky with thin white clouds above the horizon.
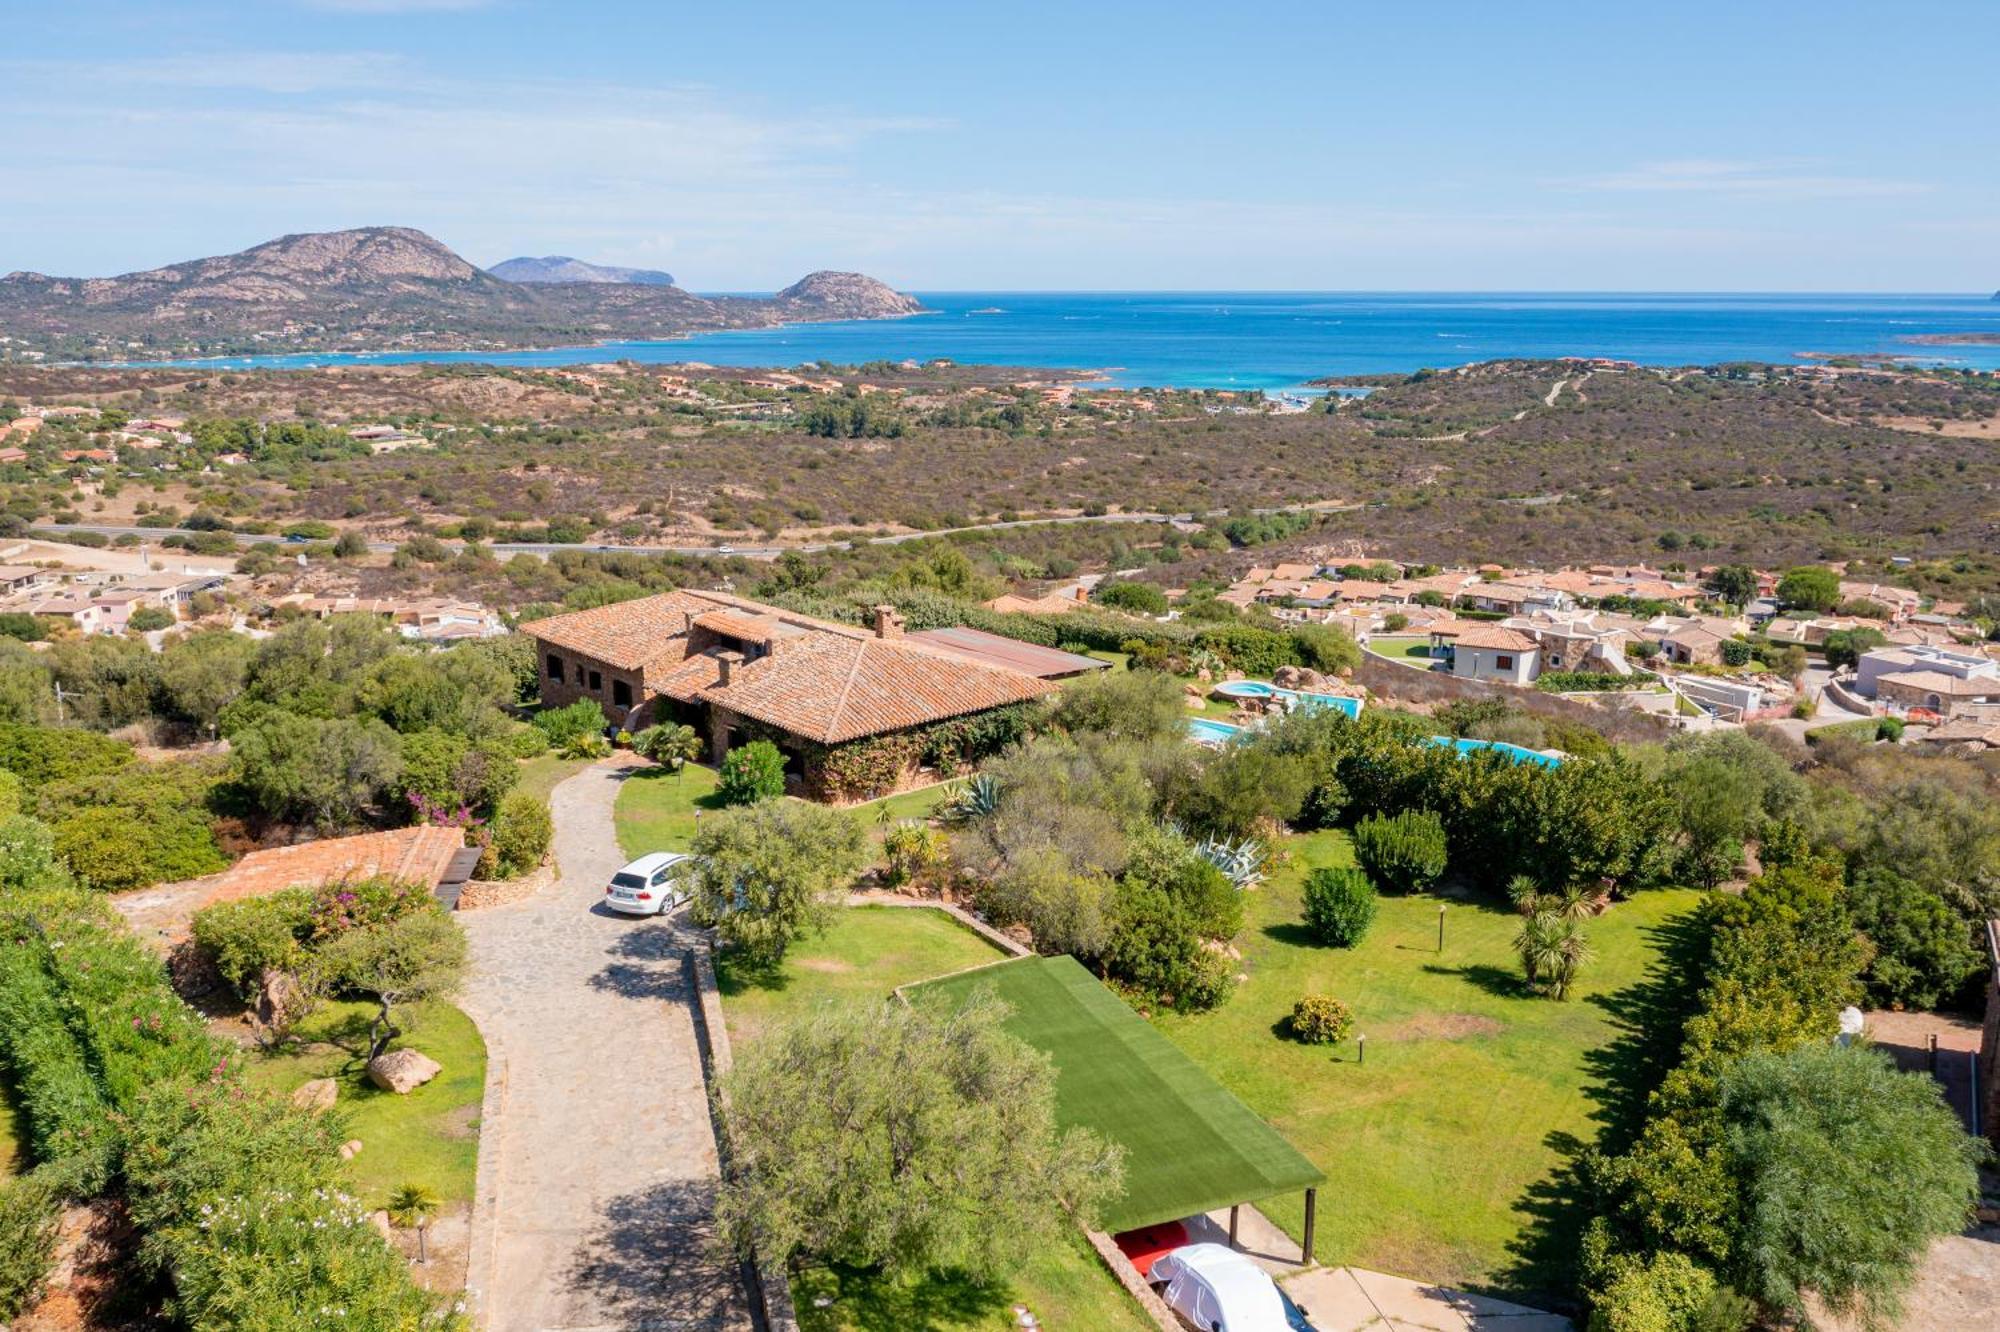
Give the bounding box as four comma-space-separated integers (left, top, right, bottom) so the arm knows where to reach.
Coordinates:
0, 0, 2000, 292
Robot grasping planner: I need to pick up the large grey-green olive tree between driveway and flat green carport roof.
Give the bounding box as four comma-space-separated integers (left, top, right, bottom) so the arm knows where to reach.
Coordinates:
716, 994, 1122, 1272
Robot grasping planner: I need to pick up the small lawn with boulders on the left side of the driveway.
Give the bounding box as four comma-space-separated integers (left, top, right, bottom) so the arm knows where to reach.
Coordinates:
248, 1002, 486, 1208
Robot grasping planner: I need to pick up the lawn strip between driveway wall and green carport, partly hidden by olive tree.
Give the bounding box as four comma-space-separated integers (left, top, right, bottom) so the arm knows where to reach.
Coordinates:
716, 906, 1152, 1332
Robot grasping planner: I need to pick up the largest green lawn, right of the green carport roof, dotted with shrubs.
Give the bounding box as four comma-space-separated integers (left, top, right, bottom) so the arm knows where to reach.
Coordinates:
1158, 832, 1698, 1296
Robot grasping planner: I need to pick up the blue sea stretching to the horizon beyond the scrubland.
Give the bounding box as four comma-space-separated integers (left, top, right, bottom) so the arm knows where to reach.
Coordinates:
148, 292, 2000, 390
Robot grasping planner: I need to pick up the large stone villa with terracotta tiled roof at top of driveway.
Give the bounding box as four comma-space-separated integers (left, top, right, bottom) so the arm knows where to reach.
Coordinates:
522, 592, 1054, 800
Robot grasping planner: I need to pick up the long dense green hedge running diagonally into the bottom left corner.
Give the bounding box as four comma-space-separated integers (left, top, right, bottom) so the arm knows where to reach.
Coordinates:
0, 890, 456, 1332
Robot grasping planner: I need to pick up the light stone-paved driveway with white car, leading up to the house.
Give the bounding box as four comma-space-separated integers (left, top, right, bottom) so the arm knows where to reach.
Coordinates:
462, 756, 750, 1332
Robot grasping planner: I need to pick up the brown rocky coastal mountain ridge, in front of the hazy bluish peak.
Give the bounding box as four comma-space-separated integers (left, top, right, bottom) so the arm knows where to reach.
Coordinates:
0, 226, 922, 360
